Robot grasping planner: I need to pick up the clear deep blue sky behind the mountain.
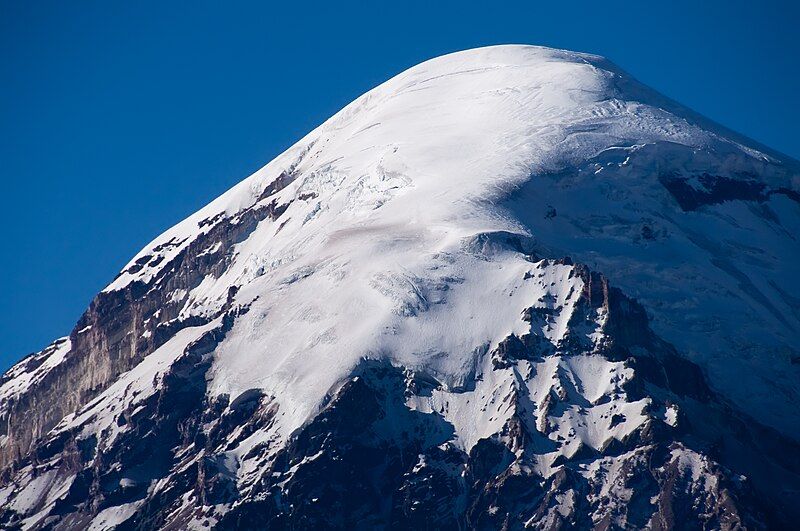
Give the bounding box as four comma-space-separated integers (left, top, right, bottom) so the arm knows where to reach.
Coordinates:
0, 0, 800, 369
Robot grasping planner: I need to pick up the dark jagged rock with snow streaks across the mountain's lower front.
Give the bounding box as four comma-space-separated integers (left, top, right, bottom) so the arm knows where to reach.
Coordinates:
0, 259, 800, 529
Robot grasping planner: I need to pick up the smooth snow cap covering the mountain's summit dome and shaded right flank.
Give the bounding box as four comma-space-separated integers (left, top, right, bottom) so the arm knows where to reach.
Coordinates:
20, 46, 800, 462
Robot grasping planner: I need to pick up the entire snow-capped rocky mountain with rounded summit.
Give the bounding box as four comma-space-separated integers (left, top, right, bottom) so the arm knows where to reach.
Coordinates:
0, 46, 800, 530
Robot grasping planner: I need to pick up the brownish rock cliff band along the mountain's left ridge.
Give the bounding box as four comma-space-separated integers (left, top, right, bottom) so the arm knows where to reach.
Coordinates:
0, 176, 290, 474
